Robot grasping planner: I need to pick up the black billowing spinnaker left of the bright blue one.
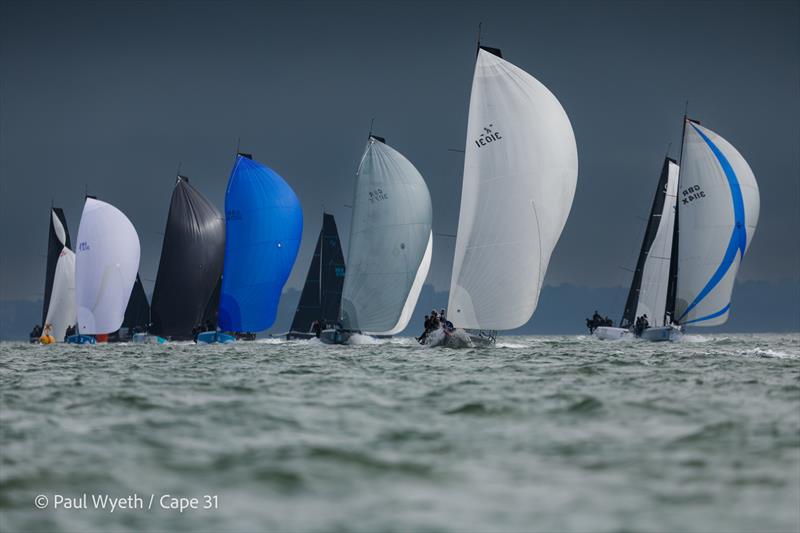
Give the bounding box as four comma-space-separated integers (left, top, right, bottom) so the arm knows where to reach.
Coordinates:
152, 176, 225, 339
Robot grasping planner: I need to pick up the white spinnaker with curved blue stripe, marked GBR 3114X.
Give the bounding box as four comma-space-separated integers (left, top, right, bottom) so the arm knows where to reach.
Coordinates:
675, 121, 759, 326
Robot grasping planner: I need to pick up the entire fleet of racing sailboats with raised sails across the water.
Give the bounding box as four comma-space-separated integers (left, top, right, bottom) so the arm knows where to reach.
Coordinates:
31, 42, 760, 348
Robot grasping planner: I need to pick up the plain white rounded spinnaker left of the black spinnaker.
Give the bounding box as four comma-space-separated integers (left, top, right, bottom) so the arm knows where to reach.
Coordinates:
75, 198, 140, 335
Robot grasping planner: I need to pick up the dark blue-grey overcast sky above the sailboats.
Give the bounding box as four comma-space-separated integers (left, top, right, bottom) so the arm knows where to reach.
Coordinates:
0, 0, 800, 300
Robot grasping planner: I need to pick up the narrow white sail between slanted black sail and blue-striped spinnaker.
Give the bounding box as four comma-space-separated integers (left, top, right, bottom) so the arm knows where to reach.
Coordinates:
636, 161, 678, 326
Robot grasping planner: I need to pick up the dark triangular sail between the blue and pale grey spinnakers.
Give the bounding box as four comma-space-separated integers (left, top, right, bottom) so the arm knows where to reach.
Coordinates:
290, 213, 345, 333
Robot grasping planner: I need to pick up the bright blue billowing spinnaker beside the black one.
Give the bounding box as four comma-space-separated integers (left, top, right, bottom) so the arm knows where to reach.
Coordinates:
219, 155, 303, 332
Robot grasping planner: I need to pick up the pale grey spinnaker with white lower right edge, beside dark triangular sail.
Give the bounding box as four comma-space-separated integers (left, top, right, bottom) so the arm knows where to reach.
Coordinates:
342, 137, 433, 335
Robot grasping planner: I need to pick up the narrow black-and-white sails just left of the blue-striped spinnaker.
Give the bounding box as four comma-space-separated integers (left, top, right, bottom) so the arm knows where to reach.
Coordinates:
621, 157, 678, 327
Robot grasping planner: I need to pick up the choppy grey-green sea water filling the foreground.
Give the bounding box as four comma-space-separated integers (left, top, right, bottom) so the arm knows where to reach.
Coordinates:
0, 335, 800, 532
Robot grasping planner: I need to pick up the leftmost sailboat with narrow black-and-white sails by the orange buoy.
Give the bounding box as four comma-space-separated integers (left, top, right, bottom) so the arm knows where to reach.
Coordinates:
41, 207, 77, 343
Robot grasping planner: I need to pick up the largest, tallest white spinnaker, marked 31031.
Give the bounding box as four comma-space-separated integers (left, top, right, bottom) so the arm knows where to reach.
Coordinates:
447, 49, 578, 329
